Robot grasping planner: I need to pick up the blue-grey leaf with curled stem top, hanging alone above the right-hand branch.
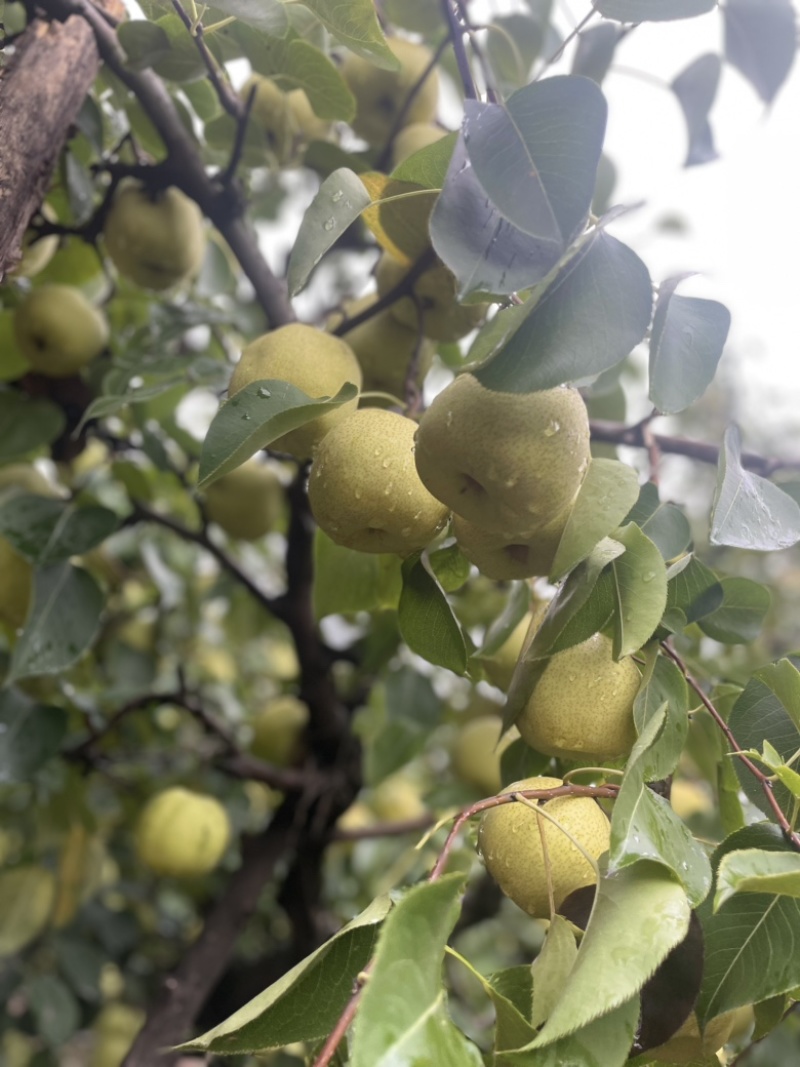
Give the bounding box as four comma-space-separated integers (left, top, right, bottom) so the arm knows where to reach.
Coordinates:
650, 278, 731, 415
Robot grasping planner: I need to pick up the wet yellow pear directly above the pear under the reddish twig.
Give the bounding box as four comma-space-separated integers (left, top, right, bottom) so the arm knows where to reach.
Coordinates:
516, 634, 641, 760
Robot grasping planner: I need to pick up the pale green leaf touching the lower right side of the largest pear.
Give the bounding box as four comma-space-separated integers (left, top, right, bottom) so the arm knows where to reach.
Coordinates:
549, 459, 639, 582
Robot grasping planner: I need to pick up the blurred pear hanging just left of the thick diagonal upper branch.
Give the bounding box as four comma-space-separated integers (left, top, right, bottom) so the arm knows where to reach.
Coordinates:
102, 180, 206, 292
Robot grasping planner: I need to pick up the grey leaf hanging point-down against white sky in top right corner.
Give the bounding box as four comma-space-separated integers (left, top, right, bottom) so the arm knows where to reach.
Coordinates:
722, 0, 797, 103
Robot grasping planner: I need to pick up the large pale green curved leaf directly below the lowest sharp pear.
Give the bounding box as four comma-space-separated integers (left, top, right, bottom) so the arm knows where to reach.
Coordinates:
532, 862, 690, 1048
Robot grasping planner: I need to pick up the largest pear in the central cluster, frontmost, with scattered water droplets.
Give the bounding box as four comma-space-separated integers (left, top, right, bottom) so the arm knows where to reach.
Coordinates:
415, 373, 590, 540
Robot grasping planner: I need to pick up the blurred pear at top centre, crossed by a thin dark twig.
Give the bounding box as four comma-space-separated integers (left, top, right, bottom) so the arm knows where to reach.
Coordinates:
341, 37, 438, 145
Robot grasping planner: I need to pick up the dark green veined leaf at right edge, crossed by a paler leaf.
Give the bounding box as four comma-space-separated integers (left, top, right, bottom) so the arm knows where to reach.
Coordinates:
697, 823, 800, 1024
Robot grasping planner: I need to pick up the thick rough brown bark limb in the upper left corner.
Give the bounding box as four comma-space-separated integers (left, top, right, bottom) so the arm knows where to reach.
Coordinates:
0, 17, 100, 281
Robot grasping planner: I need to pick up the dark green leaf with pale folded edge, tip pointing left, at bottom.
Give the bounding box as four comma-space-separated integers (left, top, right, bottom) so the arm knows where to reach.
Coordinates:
178, 896, 390, 1055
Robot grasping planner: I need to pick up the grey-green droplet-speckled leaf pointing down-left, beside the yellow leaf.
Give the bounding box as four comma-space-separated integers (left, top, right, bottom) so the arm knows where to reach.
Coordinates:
288, 166, 371, 297
